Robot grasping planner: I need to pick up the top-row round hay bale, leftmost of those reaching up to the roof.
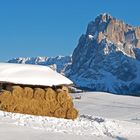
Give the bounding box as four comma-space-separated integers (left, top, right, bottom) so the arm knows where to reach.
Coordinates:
12, 86, 24, 98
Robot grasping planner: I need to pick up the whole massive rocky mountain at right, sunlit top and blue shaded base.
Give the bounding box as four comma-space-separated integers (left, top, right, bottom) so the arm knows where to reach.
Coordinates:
67, 14, 140, 95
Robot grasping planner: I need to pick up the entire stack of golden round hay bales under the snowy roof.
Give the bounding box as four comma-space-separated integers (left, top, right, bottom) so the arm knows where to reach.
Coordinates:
0, 86, 78, 120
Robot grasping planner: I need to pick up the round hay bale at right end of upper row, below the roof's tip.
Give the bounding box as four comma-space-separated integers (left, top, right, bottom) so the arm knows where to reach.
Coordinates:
57, 91, 71, 104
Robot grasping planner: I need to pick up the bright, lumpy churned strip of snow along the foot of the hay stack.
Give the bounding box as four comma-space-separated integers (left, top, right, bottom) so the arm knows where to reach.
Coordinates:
0, 111, 140, 138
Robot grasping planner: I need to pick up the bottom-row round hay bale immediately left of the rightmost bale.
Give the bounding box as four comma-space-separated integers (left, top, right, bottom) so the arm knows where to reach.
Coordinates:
54, 107, 66, 118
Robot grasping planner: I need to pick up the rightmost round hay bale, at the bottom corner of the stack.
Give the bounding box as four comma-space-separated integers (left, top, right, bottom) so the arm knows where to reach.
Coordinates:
66, 108, 78, 120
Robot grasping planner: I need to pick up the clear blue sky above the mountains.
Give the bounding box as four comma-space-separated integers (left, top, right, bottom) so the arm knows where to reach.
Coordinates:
0, 0, 140, 61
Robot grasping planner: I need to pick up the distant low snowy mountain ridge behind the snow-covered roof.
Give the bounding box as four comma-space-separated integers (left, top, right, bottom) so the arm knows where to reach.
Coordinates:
8, 56, 72, 74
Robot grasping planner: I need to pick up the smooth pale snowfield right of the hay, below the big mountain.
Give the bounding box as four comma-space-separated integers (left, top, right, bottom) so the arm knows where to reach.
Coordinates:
73, 92, 140, 123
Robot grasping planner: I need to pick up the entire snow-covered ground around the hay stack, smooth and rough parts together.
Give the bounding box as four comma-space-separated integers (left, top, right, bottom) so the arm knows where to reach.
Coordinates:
0, 93, 140, 140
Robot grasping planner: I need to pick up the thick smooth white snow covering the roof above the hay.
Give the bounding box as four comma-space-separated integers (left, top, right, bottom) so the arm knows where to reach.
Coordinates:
0, 63, 73, 86
